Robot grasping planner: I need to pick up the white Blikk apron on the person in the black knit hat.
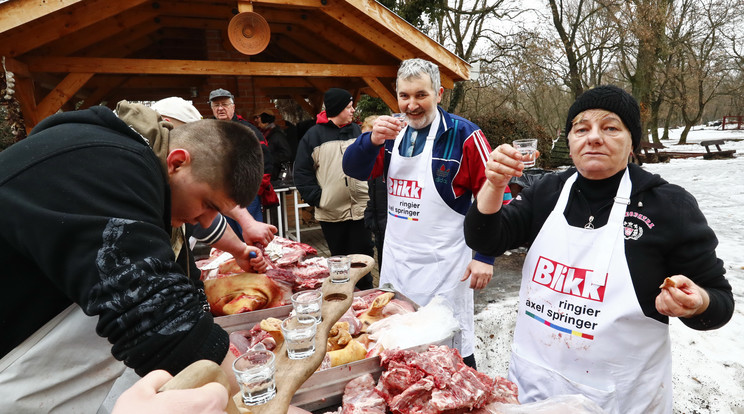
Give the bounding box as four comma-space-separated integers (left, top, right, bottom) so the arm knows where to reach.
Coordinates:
509, 170, 672, 414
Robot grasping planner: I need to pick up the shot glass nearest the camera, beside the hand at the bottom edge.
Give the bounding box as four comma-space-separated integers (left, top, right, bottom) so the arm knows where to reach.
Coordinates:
233, 349, 276, 405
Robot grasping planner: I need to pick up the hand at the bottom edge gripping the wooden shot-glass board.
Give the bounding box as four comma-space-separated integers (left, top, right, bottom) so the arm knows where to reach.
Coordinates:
112, 370, 228, 414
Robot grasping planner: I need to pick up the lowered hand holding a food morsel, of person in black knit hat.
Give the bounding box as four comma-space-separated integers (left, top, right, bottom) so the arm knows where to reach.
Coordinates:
656, 275, 710, 318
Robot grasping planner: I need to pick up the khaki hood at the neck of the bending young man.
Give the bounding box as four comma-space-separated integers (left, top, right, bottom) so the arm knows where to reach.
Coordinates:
116, 101, 173, 173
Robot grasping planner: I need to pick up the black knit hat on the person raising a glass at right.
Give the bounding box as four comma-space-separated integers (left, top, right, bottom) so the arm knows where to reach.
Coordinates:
566, 85, 642, 150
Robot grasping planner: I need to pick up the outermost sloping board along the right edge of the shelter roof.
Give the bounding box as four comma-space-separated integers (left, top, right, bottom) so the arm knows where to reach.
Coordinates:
338, 0, 470, 80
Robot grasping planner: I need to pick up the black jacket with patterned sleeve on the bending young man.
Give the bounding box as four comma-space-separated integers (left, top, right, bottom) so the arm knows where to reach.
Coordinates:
0, 107, 229, 375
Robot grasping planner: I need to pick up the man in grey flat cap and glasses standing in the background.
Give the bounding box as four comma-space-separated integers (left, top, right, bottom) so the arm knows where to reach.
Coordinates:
209, 88, 278, 235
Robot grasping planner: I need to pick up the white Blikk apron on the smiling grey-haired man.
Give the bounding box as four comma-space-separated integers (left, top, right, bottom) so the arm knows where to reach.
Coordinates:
380, 111, 474, 356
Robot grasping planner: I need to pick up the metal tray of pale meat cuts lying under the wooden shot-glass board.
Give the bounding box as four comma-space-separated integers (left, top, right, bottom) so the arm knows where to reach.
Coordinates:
215, 289, 460, 411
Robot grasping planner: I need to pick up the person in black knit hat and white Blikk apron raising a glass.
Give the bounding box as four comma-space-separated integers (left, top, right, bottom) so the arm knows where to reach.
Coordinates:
464, 85, 734, 414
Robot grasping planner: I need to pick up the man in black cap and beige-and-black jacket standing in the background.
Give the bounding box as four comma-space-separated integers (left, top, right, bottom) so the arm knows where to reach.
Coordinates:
294, 88, 374, 289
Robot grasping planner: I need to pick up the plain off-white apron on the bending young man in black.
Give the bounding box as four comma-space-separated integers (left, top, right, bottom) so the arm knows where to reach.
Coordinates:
0, 304, 125, 414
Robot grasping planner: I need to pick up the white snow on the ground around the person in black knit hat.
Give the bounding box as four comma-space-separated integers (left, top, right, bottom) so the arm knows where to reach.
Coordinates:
475, 127, 744, 414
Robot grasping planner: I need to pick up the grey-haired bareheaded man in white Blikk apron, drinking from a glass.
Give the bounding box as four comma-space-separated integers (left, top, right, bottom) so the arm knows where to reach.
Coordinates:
344, 59, 512, 367
